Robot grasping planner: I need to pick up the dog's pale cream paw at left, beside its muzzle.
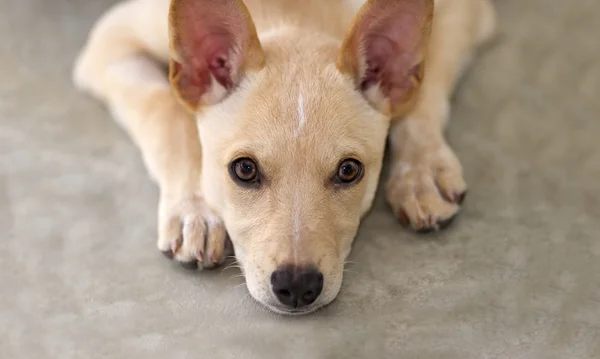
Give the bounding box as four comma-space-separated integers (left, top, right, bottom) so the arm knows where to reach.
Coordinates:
158, 196, 231, 269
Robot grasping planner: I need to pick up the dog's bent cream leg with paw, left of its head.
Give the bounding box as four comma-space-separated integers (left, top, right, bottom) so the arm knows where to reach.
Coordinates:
74, 0, 226, 267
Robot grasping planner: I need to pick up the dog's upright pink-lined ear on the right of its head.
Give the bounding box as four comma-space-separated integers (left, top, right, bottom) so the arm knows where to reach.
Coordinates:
337, 0, 433, 116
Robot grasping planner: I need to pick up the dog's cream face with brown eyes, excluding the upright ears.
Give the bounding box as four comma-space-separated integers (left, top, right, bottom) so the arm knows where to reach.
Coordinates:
199, 39, 389, 311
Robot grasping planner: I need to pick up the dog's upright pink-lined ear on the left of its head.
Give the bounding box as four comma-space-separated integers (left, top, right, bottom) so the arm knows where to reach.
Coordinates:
169, 0, 264, 111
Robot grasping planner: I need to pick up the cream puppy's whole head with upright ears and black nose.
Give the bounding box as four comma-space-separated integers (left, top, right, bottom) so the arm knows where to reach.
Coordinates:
170, 0, 433, 313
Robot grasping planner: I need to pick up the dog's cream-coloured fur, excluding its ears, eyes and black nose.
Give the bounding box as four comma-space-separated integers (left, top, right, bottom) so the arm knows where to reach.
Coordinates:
74, 0, 494, 313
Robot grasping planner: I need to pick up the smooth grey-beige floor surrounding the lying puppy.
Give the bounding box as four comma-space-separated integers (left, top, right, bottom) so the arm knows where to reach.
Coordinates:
0, 0, 600, 359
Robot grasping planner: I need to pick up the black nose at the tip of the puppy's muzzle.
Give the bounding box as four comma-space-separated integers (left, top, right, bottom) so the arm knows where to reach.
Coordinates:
271, 266, 323, 308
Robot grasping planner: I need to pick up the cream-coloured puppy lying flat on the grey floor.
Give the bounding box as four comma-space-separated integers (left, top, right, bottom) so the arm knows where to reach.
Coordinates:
74, 0, 494, 314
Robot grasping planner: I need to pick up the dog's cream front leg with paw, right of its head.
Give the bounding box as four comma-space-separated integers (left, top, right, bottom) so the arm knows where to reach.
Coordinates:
386, 0, 494, 232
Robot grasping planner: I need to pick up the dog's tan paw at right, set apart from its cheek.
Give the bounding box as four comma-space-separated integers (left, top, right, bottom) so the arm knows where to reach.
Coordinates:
386, 144, 467, 233
